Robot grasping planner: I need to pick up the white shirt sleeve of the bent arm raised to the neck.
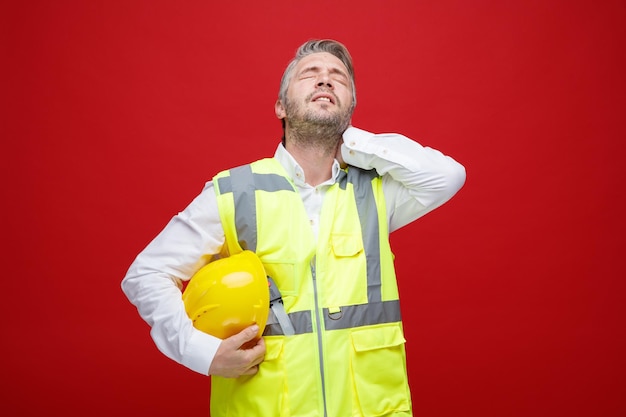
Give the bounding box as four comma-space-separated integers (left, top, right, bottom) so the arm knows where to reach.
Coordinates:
341, 127, 465, 232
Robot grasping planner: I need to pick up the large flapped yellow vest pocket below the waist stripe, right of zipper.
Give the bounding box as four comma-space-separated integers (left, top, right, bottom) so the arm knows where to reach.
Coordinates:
351, 323, 411, 416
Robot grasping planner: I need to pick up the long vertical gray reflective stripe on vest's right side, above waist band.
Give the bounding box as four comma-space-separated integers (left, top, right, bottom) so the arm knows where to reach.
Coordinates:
348, 168, 382, 303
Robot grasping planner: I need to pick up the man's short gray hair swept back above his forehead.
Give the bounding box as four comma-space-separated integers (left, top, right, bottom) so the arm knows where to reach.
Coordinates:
278, 39, 356, 109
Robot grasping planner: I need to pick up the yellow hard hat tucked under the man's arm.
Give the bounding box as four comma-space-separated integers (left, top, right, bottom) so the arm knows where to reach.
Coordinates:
183, 250, 269, 340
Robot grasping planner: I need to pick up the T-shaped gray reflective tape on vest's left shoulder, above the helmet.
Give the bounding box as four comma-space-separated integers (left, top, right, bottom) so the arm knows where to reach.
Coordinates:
218, 165, 294, 252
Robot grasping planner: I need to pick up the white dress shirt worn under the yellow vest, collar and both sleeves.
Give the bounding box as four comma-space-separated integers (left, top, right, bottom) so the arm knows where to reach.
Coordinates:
122, 127, 465, 375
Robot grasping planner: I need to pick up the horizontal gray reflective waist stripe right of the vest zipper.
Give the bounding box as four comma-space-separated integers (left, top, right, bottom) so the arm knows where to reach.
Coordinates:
324, 300, 401, 330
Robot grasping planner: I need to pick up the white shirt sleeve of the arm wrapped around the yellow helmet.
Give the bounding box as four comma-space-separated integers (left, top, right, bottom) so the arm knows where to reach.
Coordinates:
122, 182, 224, 375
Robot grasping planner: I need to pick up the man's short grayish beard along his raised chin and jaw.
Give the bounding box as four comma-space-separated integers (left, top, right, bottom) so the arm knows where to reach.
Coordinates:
286, 100, 351, 155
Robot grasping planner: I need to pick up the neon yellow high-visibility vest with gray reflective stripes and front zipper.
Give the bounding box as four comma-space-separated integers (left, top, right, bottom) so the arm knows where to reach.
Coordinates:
211, 158, 412, 417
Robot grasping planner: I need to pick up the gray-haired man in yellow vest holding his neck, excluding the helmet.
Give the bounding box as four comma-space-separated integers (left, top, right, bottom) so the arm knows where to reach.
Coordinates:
122, 40, 465, 417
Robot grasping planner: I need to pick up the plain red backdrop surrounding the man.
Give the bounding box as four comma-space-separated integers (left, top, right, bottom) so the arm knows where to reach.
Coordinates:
0, 0, 626, 417
